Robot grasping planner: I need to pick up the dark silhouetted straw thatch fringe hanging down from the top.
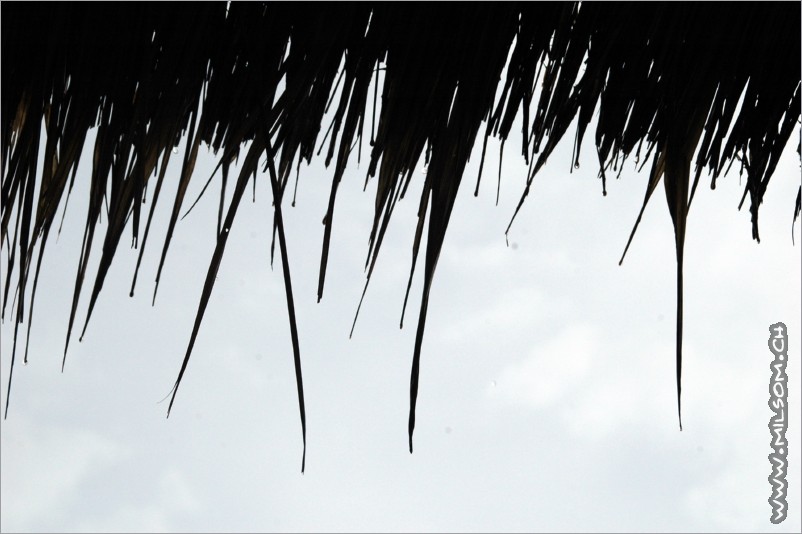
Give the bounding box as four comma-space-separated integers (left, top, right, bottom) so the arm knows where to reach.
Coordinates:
0, 2, 800, 472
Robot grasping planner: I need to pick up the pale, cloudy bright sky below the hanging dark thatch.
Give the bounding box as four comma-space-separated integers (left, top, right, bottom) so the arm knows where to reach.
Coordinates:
0, 59, 802, 532
